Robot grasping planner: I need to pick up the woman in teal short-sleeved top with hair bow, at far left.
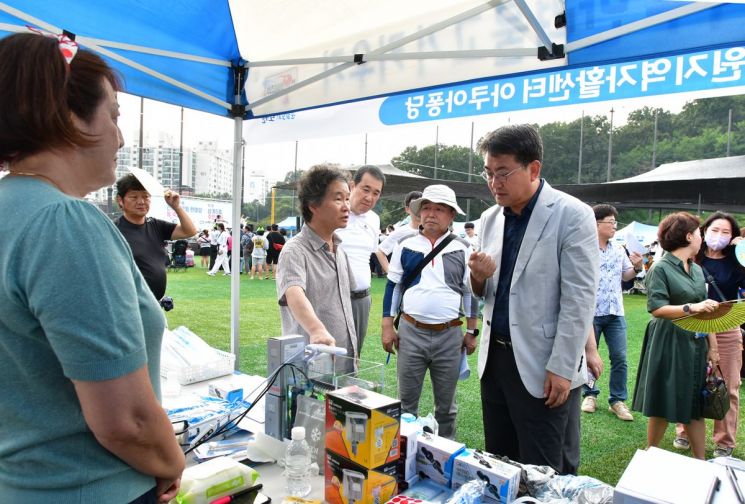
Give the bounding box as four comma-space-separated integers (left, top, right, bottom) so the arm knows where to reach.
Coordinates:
0, 33, 184, 504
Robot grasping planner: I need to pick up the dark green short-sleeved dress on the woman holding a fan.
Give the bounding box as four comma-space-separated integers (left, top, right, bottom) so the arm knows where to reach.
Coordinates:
633, 253, 708, 424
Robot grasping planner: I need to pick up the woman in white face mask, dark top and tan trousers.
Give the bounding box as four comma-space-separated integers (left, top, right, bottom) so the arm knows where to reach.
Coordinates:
673, 212, 745, 457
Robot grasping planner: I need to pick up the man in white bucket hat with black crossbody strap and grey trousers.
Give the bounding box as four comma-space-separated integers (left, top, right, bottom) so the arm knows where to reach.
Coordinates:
382, 184, 478, 438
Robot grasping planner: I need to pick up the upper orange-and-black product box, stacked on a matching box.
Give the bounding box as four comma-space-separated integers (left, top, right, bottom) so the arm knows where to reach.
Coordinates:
326, 385, 401, 469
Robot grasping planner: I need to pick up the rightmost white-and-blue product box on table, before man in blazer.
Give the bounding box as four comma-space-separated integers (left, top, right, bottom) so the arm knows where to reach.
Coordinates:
452, 450, 520, 504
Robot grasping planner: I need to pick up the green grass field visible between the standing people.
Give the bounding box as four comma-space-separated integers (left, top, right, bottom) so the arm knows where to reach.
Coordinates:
167, 267, 745, 485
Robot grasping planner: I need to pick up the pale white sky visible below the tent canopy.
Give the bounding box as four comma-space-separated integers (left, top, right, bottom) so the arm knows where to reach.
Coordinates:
119, 87, 745, 190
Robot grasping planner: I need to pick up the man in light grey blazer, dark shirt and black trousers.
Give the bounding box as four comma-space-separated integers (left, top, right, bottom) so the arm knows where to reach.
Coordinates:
469, 125, 599, 474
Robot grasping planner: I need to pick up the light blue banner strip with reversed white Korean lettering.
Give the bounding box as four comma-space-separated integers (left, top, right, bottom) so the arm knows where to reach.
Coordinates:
379, 47, 745, 125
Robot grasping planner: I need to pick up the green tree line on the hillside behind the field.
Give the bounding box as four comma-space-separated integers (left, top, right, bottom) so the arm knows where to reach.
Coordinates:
243, 96, 745, 225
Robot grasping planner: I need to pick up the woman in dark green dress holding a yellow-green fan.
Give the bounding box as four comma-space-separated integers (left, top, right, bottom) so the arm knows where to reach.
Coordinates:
633, 212, 718, 459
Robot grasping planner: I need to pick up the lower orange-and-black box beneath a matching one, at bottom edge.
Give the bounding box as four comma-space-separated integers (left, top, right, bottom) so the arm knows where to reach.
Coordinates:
324, 450, 398, 504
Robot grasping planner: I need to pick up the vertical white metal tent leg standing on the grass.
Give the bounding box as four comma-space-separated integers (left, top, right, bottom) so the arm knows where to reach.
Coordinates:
230, 117, 243, 370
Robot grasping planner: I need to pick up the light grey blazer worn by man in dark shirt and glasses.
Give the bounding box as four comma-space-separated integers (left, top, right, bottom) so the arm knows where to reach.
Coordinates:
478, 182, 600, 397
